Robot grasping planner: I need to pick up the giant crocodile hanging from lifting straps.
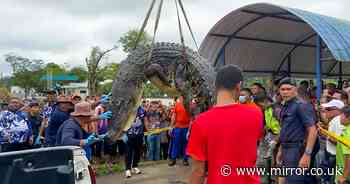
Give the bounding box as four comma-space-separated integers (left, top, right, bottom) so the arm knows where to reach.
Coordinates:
109, 42, 216, 140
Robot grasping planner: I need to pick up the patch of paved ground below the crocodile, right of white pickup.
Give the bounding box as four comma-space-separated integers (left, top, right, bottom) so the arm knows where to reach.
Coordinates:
97, 162, 191, 184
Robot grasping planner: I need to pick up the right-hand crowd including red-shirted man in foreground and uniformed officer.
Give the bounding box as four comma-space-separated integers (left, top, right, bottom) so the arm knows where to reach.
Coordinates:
187, 65, 350, 184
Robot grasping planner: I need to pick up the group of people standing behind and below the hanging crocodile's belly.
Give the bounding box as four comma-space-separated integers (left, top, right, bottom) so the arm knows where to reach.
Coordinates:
124, 96, 191, 177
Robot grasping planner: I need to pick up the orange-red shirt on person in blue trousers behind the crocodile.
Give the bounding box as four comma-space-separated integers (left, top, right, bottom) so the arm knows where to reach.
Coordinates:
174, 102, 191, 128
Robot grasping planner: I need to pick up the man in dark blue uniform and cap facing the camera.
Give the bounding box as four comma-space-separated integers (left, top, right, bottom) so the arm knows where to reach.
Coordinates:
276, 78, 318, 184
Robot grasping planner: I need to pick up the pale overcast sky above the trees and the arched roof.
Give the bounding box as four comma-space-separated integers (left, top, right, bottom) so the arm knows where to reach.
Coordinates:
0, 0, 350, 75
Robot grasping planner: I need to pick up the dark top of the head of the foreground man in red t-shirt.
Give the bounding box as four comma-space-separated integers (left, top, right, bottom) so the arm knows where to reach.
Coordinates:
215, 64, 243, 89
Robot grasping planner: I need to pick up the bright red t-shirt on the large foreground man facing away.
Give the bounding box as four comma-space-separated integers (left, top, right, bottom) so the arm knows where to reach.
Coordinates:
187, 104, 263, 184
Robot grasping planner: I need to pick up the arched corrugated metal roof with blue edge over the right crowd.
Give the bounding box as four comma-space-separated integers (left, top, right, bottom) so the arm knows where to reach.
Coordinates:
200, 3, 350, 76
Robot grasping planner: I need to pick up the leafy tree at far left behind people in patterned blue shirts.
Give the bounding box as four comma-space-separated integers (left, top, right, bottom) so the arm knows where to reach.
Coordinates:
5, 54, 44, 98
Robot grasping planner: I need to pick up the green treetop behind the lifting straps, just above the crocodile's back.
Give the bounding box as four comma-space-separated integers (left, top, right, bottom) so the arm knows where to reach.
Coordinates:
119, 29, 152, 53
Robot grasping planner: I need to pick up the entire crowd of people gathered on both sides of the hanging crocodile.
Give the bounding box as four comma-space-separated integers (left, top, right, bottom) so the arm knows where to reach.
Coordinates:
0, 65, 350, 184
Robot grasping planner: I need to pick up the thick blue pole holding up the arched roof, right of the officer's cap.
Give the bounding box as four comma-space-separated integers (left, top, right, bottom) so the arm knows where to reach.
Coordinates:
316, 35, 322, 102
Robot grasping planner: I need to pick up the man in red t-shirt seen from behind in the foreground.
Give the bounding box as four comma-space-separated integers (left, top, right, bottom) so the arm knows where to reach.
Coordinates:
187, 65, 263, 184
